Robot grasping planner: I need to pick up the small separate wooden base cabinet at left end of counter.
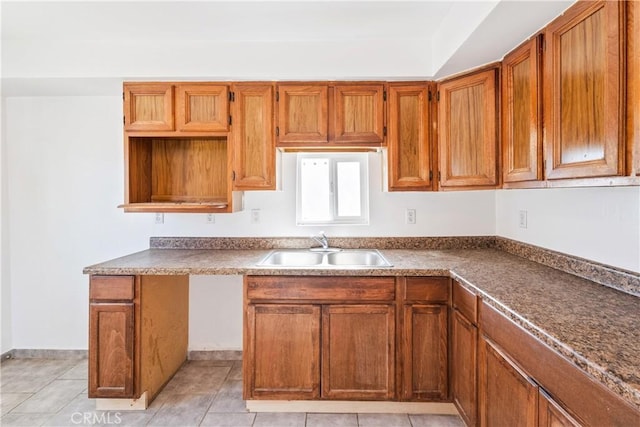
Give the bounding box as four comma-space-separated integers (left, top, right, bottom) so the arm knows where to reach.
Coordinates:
88, 275, 189, 410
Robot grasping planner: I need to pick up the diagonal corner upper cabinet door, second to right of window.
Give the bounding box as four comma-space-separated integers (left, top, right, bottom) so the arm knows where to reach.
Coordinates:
438, 69, 498, 187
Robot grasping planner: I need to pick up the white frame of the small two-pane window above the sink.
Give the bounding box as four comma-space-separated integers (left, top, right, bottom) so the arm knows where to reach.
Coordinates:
296, 153, 369, 225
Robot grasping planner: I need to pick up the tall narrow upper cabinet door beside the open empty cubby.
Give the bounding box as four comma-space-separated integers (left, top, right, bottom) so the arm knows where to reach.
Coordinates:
232, 84, 276, 190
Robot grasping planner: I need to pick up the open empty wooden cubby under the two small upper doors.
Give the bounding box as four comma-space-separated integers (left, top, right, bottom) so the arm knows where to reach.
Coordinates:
124, 137, 230, 212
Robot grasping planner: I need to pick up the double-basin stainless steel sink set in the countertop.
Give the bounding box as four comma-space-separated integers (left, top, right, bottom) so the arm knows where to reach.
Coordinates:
257, 249, 393, 269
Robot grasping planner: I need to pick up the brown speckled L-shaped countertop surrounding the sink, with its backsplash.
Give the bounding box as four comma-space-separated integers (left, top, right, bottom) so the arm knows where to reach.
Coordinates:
84, 238, 640, 409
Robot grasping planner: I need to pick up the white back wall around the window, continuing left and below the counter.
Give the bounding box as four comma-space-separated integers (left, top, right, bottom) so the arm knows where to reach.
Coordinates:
3, 94, 495, 350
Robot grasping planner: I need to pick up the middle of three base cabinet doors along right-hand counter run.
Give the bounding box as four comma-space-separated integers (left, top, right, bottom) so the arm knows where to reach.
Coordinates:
478, 337, 538, 427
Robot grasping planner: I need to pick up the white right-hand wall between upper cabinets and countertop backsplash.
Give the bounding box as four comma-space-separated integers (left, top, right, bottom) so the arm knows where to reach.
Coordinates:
496, 187, 640, 272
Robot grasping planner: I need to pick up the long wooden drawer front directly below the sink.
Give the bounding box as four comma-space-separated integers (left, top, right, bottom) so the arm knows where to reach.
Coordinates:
245, 276, 395, 301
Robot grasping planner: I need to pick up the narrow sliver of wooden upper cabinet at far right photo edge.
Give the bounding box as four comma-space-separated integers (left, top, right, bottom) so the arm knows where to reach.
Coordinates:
627, 1, 640, 175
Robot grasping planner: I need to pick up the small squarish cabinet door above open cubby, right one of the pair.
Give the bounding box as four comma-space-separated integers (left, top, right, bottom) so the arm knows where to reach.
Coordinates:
176, 83, 229, 132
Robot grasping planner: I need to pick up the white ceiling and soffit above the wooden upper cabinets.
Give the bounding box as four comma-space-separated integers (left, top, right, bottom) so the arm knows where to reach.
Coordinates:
0, 0, 574, 96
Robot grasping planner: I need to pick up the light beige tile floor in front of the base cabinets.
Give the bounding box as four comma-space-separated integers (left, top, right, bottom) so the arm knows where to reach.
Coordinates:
0, 359, 464, 427
